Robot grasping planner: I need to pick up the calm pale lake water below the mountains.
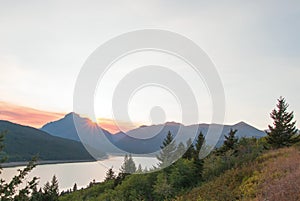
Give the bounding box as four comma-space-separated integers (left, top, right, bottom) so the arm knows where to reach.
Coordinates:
1, 157, 157, 191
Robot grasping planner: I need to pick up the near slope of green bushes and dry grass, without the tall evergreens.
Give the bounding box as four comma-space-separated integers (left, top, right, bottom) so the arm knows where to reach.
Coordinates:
59, 135, 300, 201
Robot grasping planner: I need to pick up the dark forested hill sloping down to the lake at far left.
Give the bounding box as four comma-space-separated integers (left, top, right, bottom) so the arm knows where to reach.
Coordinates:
0, 120, 104, 162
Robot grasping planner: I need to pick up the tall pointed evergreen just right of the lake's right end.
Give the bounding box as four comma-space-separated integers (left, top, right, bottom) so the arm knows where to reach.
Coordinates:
156, 131, 176, 168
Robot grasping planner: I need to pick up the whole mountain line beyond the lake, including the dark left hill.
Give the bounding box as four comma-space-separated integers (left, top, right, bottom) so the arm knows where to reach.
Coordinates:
0, 112, 265, 161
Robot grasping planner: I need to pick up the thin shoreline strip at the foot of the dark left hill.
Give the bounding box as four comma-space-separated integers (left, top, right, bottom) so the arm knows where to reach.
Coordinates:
1, 159, 96, 168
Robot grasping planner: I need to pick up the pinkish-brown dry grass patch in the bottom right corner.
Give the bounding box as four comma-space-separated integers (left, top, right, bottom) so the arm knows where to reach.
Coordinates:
256, 148, 300, 201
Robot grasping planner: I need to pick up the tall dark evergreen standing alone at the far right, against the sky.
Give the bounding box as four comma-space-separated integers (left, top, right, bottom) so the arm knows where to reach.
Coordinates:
266, 97, 300, 148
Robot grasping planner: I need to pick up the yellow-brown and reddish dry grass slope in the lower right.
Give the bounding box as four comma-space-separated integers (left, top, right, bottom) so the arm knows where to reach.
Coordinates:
177, 147, 300, 201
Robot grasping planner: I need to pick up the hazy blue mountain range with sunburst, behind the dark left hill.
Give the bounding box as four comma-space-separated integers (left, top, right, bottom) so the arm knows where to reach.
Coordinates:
41, 113, 265, 154
